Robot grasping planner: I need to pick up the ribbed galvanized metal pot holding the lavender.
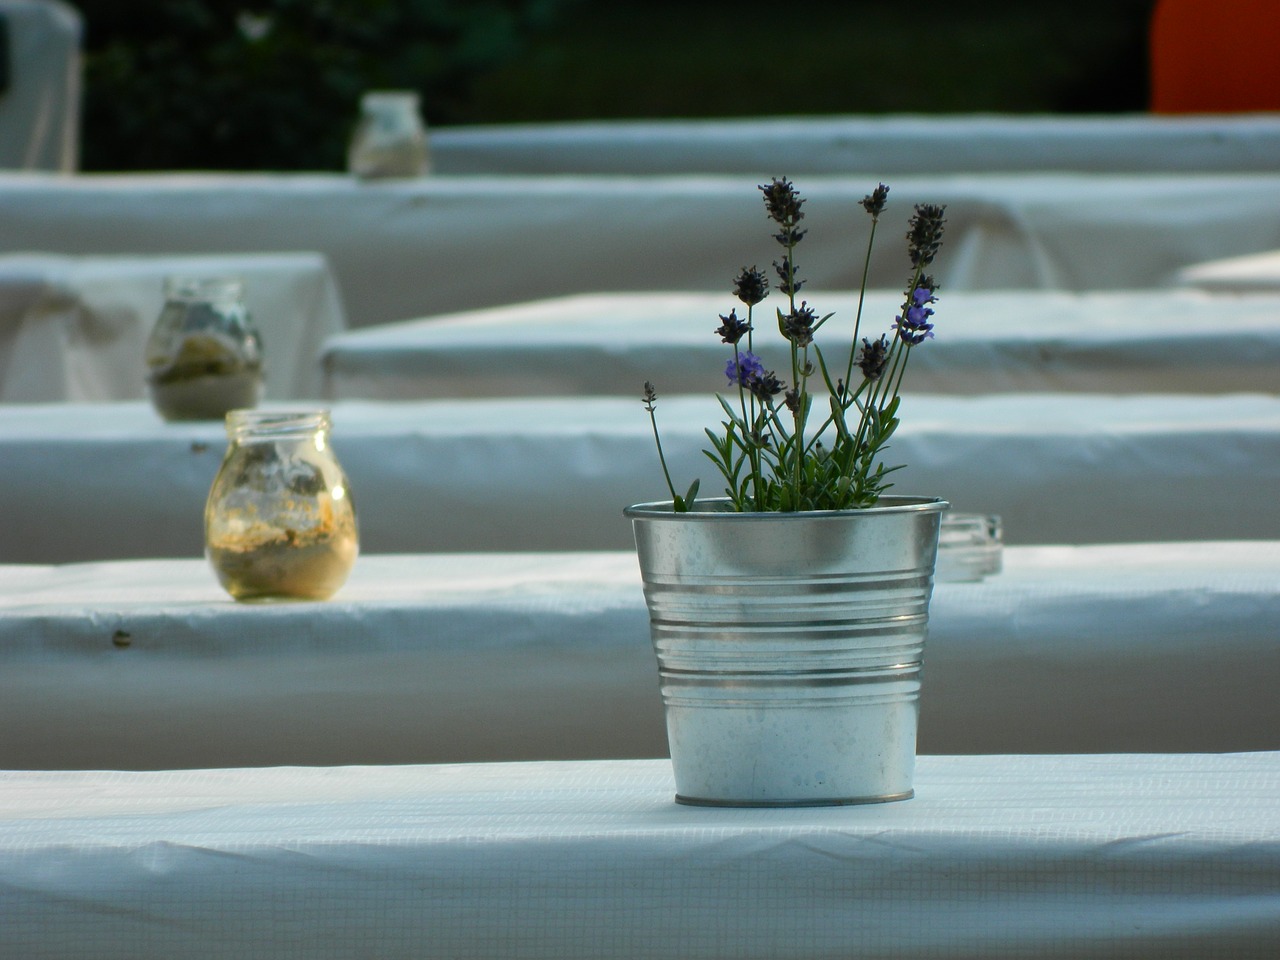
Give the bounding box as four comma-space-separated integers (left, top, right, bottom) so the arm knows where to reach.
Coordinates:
625, 497, 948, 806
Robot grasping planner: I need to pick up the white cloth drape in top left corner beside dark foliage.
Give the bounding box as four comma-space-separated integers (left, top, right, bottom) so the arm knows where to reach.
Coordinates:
0, 0, 83, 173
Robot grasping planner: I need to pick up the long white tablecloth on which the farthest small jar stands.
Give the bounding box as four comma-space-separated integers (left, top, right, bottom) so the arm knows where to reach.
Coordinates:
0, 169, 1280, 326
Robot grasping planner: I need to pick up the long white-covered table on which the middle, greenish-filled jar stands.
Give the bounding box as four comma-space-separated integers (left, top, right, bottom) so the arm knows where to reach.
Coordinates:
0, 393, 1280, 563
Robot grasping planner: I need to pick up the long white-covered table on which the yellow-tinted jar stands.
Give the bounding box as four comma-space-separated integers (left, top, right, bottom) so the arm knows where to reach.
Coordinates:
0, 540, 1280, 769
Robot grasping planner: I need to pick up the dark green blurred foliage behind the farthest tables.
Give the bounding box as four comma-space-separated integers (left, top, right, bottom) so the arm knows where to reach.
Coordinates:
79, 0, 1153, 170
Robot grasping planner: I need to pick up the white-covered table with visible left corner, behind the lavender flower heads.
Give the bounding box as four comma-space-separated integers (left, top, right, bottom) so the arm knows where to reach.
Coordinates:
321, 284, 1280, 399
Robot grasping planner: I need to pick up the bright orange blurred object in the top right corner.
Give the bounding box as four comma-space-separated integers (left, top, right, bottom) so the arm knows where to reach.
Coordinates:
1151, 0, 1280, 114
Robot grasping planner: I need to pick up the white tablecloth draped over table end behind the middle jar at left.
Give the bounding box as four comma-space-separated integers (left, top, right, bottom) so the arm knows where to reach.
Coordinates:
0, 253, 346, 403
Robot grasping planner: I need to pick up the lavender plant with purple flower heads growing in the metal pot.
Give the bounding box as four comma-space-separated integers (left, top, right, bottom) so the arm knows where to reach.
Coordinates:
644, 178, 946, 512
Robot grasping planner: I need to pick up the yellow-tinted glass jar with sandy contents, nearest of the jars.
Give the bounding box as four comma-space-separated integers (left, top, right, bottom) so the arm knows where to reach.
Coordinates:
205, 410, 360, 600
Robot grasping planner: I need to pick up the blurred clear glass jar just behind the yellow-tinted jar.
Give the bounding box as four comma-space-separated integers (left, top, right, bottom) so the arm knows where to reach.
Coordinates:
145, 276, 262, 420
